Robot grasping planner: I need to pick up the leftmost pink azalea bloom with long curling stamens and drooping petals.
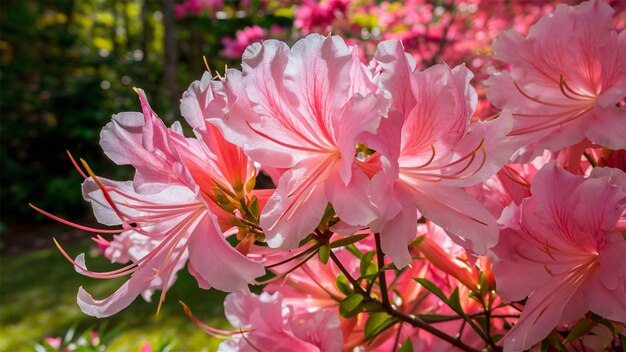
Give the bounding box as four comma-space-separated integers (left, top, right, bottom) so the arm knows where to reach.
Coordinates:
40, 87, 265, 317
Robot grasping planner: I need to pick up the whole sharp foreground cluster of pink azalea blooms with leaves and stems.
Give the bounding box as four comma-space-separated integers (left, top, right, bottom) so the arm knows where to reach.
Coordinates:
36, 0, 626, 351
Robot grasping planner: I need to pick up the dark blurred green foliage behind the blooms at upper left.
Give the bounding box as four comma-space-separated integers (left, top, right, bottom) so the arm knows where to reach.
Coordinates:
0, 0, 292, 225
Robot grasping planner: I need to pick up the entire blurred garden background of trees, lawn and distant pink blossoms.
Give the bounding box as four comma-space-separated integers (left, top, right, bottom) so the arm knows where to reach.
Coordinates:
0, 0, 626, 351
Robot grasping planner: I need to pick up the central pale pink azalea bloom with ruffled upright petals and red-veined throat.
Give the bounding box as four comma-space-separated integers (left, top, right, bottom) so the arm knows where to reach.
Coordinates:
212, 35, 389, 248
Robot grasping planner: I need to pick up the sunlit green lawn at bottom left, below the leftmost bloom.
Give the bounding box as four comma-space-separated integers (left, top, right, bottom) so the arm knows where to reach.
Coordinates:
0, 240, 228, 352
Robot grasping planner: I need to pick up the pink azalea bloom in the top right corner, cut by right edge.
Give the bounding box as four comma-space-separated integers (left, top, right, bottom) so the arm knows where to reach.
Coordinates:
487, 1, 626, 160
